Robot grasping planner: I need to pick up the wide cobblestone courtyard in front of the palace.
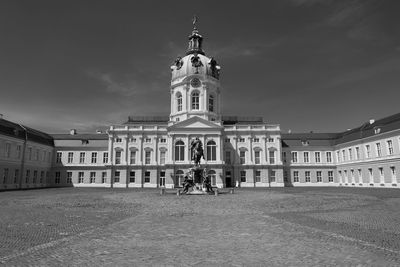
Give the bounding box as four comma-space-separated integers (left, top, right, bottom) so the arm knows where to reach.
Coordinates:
0, 188, 400, 266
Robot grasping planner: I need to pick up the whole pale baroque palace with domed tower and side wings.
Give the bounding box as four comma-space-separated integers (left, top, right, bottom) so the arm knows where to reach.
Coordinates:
0, 24, 400, 190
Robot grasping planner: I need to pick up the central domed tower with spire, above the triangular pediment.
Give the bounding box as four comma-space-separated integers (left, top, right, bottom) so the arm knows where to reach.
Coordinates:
170, 20, 221, 124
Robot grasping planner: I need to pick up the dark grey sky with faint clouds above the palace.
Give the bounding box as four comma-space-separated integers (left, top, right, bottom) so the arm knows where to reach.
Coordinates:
0, 0, 400, 133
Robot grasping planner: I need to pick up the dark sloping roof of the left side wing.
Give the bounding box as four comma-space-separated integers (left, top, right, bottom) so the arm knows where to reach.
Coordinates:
0, 119, 54, 146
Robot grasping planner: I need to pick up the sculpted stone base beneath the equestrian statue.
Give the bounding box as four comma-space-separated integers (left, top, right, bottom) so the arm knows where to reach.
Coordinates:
182, 165, 214, 195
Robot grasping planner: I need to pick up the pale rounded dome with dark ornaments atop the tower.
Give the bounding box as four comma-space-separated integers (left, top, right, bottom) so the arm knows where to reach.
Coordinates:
171, 53, 221, 81
